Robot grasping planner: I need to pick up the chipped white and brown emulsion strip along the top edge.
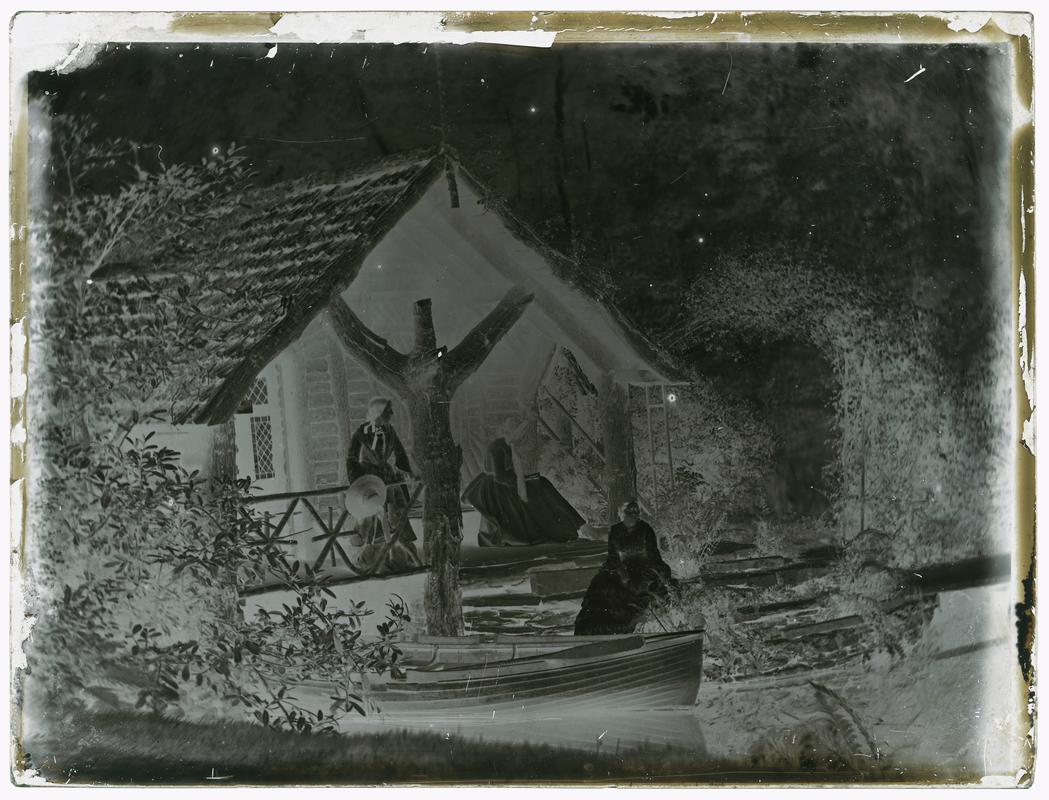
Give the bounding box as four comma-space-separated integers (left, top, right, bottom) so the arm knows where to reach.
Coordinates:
4, 12, 1044, 77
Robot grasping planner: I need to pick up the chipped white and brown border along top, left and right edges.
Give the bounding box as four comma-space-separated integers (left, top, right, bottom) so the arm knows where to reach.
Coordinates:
9, 12, 1034, 784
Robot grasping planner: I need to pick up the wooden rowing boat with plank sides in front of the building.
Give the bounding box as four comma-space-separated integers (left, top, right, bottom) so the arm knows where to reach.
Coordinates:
296, 630, 703, 718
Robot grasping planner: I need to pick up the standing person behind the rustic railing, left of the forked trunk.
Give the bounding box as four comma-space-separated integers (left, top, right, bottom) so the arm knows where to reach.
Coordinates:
346, 397, 422, 570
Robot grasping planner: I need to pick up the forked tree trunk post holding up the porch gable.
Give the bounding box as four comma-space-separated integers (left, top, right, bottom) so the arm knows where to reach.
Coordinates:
329, 287, 532, 636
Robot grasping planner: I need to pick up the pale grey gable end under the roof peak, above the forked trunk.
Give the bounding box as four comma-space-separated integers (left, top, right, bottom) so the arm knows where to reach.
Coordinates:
360, 167, 677, 392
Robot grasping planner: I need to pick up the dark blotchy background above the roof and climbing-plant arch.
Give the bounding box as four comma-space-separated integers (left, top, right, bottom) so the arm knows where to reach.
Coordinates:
30, 44, 1006, 520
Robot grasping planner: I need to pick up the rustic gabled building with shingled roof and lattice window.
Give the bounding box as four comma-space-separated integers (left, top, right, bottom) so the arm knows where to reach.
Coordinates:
96, 153, 684, 563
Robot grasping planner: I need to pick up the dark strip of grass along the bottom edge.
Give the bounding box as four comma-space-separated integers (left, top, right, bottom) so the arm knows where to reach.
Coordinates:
19, 714, 963, 785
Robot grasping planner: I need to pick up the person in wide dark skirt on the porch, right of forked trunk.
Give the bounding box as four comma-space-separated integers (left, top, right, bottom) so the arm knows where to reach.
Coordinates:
463, 408, 586, 547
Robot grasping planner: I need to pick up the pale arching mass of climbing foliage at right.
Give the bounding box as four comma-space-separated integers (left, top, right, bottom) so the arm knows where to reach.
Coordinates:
682, 250, 1010, 564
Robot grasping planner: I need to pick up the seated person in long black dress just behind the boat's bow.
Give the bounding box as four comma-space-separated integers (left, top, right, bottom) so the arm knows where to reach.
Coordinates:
575, 499, 678, 636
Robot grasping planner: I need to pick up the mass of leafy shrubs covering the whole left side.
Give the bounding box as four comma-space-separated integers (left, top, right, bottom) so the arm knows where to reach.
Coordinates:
26, 108, 407, 731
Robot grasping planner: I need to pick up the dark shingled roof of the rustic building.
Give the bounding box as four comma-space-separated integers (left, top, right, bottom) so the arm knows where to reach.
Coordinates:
98, 151, 681, 424
